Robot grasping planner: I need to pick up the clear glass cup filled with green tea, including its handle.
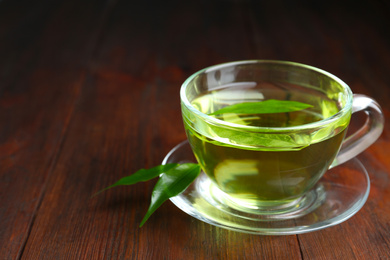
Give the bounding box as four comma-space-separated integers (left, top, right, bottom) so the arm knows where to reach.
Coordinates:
181, 61, 383, 214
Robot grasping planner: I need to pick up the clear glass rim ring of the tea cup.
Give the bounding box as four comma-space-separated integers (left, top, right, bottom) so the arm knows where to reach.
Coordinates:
180, 60, 353, 132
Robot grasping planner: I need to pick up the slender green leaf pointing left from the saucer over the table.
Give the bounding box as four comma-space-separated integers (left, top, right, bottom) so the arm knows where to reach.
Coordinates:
95, 163, 178, 195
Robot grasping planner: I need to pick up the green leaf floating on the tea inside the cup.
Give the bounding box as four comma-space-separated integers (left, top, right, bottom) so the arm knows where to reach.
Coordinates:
209, 99, 313, 115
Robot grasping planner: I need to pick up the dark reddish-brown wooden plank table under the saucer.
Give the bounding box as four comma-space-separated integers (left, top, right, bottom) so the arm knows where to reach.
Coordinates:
0, 0, 390, 259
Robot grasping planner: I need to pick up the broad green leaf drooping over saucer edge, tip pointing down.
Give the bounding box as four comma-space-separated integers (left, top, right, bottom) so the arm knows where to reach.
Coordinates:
140, 163, 200, 227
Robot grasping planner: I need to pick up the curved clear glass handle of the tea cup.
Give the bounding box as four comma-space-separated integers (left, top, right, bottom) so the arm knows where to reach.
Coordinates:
330, 94, 384, 168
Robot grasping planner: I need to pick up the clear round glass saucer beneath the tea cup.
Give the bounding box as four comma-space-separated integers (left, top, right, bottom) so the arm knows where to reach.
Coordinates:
163, 141, 370, 235
